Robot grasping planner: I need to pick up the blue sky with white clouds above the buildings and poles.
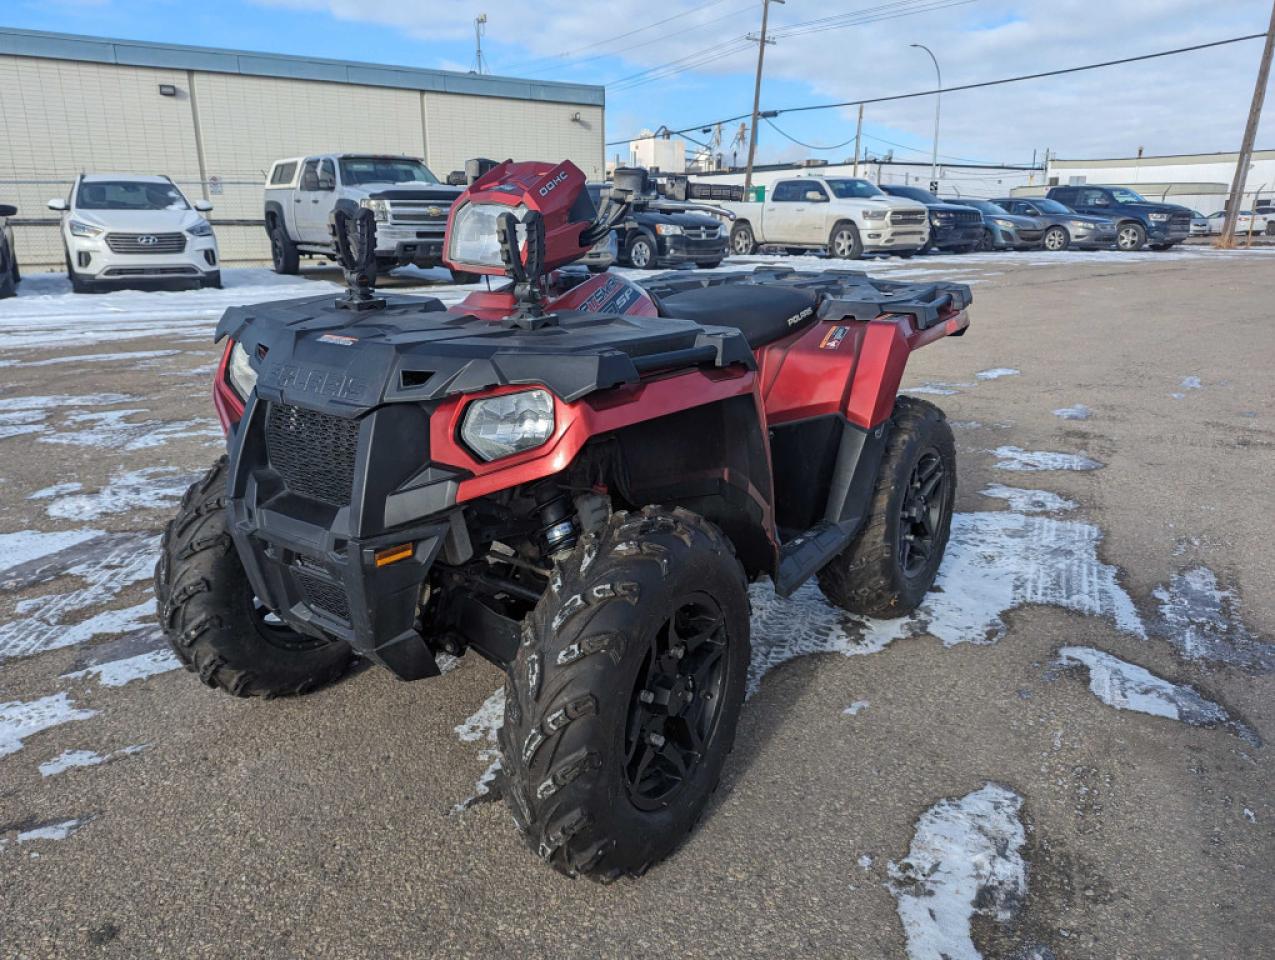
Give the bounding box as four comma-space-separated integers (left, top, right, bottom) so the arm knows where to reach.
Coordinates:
9, 0, 1275, 163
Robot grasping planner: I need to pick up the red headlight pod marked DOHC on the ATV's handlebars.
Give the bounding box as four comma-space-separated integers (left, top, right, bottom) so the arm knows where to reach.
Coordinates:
444, 161, 597, 274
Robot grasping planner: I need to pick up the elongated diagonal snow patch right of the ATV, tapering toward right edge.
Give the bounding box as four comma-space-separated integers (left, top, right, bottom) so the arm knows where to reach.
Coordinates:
1057, 646, 1260, 746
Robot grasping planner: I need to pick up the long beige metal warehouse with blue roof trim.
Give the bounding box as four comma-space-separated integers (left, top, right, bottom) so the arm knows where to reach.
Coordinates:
0, 27, 604, 268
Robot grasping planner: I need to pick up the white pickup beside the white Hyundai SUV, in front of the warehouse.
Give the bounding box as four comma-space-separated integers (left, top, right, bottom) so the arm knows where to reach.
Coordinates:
265, 153, 476, 283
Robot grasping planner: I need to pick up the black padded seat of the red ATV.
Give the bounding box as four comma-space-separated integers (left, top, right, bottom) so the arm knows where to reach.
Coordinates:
659, 283, 819, 348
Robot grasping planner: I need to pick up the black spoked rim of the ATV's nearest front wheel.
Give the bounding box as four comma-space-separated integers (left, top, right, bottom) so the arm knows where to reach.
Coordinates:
623, 593, 728, 810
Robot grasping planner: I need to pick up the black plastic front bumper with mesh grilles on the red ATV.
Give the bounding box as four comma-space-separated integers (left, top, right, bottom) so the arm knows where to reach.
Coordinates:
228, 395, 458, 680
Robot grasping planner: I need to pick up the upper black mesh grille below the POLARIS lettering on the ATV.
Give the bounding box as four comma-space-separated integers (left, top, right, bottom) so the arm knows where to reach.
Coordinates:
265, 403, 358, 506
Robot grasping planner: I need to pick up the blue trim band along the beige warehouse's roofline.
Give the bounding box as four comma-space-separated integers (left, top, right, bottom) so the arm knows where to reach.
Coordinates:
0, 27, 606, 107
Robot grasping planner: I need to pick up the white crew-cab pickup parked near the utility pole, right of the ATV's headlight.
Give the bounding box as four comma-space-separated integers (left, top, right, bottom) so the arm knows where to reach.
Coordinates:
715, 176, 929, 260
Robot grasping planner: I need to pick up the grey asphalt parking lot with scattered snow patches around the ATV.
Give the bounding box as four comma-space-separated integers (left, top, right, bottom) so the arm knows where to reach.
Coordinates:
0, 249, 1275, 960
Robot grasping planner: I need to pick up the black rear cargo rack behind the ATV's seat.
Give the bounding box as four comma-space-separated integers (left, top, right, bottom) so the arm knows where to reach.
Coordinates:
641, 266, 973, 330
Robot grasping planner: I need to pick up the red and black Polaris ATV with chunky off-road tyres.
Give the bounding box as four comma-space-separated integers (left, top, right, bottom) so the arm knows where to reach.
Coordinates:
156, 161, 970, 880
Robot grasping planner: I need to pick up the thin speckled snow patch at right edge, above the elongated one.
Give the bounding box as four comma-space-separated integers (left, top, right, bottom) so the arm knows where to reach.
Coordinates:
1153, 566, 1275, 673
